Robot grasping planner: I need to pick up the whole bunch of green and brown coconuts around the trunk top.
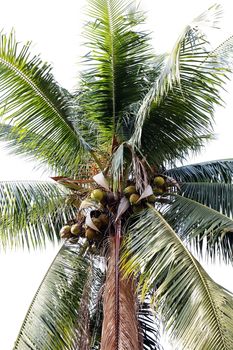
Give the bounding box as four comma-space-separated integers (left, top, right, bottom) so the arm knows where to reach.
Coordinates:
60, 176, 168, 245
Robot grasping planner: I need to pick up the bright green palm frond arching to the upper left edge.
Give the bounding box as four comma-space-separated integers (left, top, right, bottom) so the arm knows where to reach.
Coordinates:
0, 32, 93, 174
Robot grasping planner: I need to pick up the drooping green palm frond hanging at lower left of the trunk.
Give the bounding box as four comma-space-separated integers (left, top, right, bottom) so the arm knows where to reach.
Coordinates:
14, 244, 102, 350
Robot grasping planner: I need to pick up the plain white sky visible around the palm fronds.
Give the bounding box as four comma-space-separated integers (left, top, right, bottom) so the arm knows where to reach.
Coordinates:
0, 0, 233, 350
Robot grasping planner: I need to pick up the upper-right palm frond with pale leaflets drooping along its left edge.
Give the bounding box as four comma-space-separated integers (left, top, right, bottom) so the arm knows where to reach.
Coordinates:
130, 7, 233, 162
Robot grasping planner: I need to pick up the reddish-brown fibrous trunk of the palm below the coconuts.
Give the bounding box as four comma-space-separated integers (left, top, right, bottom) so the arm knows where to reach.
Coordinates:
101, 237, 142, 350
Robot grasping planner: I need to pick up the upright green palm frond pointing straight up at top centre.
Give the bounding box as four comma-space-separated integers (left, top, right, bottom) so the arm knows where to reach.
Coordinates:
80, 0, 152, 138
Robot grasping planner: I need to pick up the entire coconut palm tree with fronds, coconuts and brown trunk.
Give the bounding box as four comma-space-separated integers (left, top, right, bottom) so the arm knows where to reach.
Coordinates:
0, 0, 233, 350
